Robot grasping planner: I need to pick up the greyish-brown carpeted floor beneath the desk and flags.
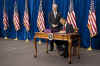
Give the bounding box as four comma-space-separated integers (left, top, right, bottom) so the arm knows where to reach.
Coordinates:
0, 39, 100, 66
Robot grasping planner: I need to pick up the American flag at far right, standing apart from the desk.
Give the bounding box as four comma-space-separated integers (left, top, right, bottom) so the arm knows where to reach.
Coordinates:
88, 1, 97, 37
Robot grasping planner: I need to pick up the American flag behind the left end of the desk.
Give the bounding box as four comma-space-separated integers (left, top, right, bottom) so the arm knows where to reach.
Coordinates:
37, 0, 45, 32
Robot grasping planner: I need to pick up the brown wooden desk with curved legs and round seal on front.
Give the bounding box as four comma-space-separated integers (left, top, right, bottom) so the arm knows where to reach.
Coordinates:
34, 32, 80, 64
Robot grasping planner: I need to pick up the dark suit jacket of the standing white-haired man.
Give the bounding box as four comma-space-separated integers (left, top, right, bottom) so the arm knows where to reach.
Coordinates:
48, 11, 63, 32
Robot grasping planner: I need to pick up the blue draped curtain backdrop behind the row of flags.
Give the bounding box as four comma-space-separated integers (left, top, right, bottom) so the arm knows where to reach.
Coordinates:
0, 0, 100, 49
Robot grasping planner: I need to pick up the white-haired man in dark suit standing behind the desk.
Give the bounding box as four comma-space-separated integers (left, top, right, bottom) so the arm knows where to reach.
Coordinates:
48, 4, 63, 51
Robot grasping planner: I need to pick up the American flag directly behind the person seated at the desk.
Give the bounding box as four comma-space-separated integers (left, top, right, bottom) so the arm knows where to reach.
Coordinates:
67, 0, 77, 29
